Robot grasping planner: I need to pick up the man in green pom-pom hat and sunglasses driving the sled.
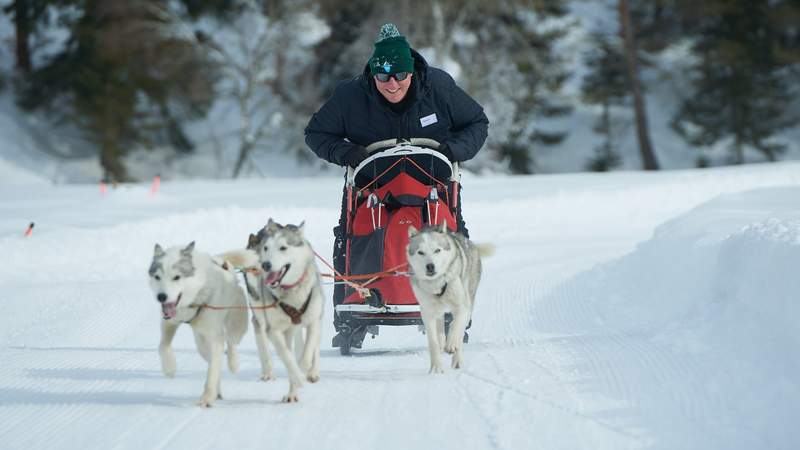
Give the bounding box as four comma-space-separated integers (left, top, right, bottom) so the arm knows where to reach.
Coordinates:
305, 23, 489, 340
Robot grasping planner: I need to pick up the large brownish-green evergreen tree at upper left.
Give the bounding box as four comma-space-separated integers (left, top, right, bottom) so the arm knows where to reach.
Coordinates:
19, 0, 220, 181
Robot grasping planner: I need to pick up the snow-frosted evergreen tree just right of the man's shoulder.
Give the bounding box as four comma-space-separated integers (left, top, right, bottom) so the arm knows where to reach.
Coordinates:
454, 0, 571, 174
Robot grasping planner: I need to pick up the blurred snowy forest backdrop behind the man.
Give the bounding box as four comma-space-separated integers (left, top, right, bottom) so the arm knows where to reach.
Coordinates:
0, 0, 800, 183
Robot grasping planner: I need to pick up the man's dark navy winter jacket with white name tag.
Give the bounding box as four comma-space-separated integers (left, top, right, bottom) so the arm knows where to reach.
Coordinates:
305, 49, 489, 166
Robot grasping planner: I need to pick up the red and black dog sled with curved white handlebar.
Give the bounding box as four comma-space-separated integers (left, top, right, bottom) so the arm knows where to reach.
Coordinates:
332, 139, 466, 355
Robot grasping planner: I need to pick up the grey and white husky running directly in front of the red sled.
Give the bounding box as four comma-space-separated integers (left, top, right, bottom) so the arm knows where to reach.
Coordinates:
408, 223, 493, 373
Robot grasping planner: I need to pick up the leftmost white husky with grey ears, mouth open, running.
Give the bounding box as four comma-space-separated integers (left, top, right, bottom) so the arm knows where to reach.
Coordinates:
149, 242, 247, 407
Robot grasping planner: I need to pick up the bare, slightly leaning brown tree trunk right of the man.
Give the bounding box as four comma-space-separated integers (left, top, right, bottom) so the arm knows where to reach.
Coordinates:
619, 0, 658, 170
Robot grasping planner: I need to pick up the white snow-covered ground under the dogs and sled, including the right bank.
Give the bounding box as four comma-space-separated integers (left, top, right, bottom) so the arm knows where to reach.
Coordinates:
0, 163, 800, 450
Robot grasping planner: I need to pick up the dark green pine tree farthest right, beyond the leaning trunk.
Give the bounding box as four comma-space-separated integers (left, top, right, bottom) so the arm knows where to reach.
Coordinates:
673, 0, 797, 164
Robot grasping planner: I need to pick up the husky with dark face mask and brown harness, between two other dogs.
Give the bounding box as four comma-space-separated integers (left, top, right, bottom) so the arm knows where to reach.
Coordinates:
248, 219, 324, 403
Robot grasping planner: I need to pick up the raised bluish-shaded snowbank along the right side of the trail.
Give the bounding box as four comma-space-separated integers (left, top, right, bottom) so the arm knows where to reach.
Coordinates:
535, 187, 800, 449
